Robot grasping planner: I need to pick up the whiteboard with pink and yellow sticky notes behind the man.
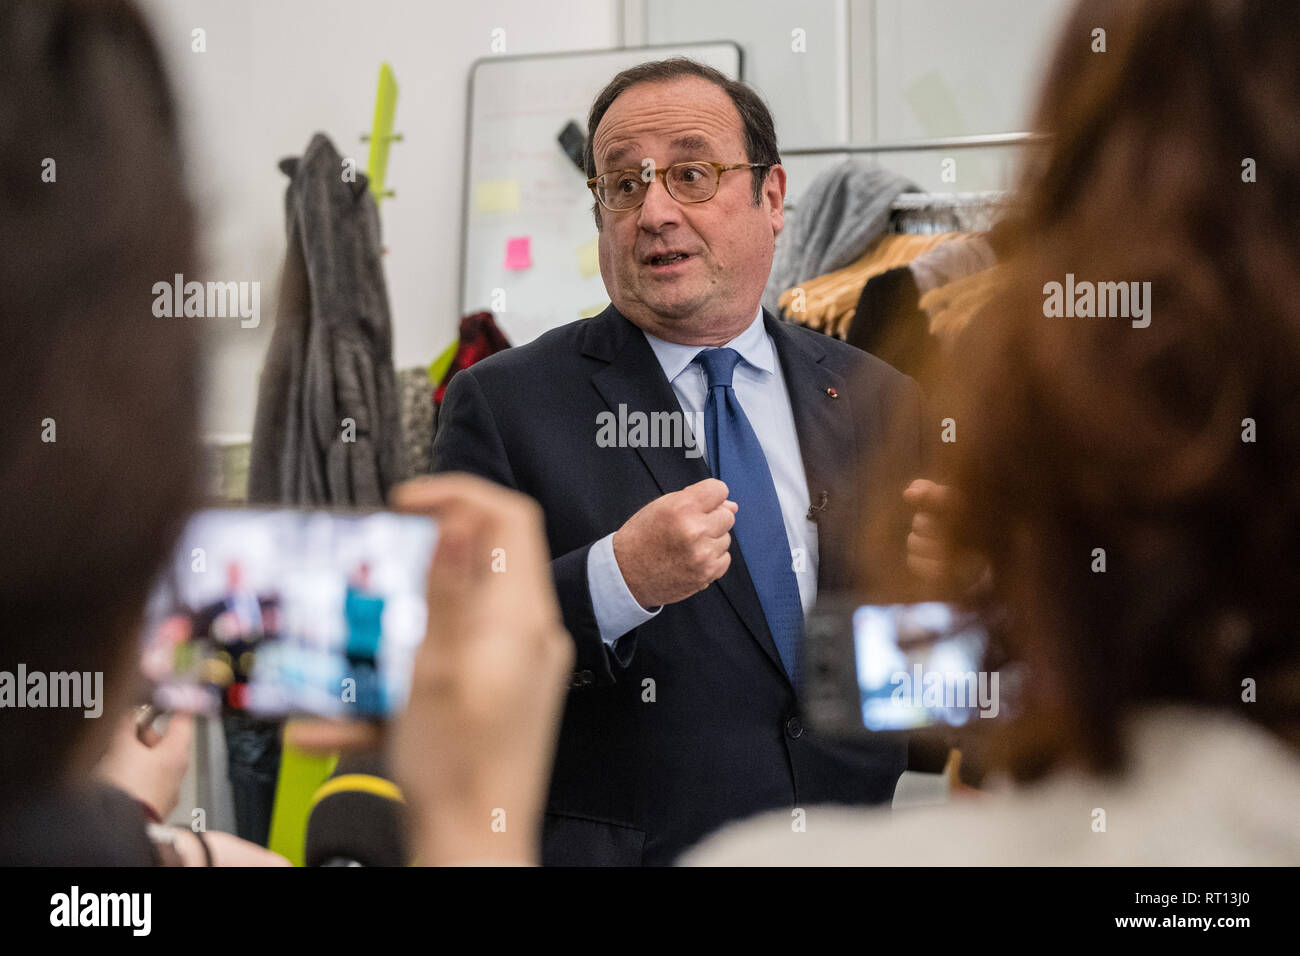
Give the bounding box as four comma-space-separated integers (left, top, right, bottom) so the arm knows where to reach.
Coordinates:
460, 42, 742, 345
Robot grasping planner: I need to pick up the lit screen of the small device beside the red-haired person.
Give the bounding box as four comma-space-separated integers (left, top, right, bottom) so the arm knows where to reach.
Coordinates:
853, 601, 1000, 731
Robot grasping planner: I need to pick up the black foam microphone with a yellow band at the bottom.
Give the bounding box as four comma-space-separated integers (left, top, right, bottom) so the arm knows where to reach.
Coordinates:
303, 754, 411, 866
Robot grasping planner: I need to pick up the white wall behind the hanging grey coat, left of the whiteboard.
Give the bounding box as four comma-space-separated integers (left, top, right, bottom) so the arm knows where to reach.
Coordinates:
140, 0, 619, 433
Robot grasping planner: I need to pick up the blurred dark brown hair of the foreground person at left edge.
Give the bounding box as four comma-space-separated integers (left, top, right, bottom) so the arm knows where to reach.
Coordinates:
0, 0, 199, 795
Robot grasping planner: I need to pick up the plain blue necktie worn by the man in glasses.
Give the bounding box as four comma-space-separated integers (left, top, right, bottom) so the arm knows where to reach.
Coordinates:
696, 349, 803, 688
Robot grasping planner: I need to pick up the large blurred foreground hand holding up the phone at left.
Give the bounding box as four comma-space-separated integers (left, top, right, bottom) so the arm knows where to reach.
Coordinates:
390, 475, 573, 865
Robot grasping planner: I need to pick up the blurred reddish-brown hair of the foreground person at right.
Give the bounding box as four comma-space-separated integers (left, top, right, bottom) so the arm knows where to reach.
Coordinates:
904, 0, 1300, 778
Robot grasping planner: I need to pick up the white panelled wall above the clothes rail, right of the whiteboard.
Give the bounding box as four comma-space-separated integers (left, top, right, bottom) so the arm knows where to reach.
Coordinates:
632, 0, 1074, 202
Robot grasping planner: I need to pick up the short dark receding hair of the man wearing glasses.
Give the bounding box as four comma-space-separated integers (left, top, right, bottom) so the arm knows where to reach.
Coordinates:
582, 56, 781, 225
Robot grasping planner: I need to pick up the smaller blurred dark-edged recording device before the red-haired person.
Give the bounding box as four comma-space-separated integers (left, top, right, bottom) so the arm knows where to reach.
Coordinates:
803, 598, 1004, 736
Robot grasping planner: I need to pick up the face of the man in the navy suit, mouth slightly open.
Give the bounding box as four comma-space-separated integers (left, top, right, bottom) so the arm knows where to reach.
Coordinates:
592, 77, 785, 345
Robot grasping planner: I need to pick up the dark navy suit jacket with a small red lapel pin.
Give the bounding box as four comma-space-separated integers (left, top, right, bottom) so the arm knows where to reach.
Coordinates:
433, 306, 924, 865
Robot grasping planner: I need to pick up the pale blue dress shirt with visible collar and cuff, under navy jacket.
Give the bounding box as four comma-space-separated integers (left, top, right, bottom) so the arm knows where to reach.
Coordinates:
586, 307, 818, 645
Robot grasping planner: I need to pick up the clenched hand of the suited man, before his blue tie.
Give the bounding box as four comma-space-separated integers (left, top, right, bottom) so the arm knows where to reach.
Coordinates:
614, 479, 738, 609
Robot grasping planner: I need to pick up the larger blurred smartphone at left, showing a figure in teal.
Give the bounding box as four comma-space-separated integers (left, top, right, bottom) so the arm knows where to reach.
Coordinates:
142, 509, 437, 719
